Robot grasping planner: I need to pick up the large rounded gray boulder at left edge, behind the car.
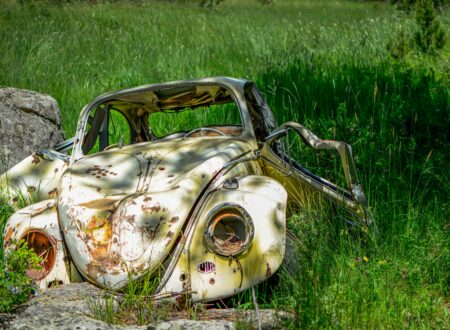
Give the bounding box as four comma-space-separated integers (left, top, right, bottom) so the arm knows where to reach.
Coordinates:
0, 88, 64, 174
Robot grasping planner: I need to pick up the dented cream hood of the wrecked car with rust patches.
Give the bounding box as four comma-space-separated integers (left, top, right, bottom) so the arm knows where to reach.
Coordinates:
58, 137, 249, 288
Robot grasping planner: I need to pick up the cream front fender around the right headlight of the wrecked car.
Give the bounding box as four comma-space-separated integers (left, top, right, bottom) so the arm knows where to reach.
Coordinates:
160, 175, 287, 301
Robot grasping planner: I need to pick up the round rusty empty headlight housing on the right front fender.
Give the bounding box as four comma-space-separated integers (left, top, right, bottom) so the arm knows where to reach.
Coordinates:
205, 203, 255, 257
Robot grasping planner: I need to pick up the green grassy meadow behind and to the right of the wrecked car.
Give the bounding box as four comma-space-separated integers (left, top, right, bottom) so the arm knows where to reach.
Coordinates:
0, 0, 450, 328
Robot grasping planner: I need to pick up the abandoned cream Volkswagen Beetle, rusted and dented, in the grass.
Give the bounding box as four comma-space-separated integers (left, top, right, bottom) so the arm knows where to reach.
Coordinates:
0, 77, 371, 302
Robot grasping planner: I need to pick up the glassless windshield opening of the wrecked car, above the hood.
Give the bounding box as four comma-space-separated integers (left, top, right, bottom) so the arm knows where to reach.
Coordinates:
82, 84, 244, 155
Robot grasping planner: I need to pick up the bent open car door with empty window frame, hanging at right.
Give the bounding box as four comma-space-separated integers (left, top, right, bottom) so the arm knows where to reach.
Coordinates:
261, 122, 372, 225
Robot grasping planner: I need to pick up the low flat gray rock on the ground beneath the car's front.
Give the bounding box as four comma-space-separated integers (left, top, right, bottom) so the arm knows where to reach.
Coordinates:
0, 282, 292, 330
